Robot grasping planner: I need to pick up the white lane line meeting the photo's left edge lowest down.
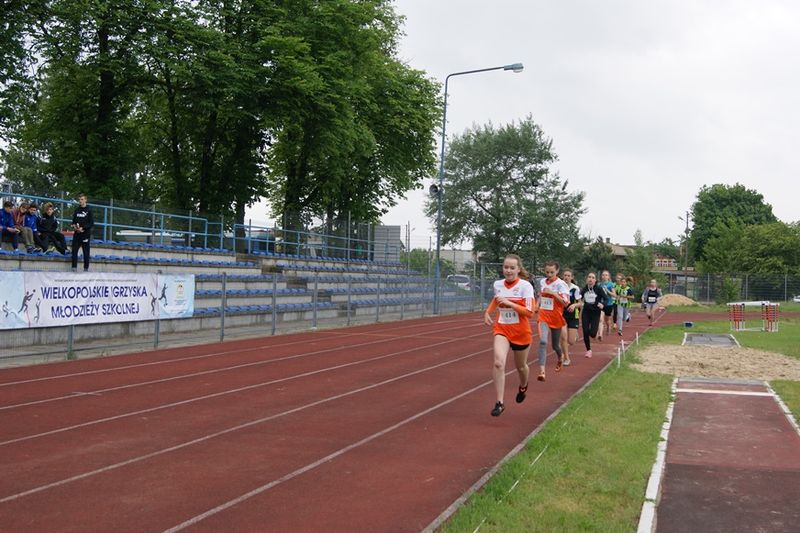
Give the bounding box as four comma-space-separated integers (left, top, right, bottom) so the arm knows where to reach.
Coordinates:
0, 349, 492, 503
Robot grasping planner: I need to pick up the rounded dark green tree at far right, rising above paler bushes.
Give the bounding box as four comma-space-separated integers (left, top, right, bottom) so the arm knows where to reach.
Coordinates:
690, 183, 777, 260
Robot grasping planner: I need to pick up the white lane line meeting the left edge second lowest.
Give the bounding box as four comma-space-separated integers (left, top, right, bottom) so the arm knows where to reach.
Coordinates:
0, 332, 485, 446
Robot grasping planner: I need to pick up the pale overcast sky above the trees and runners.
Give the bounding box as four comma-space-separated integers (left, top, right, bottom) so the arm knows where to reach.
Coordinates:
383, 0, 800, 247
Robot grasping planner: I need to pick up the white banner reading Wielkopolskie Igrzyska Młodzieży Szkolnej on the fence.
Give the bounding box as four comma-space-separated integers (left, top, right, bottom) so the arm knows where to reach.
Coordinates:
0, 271, 194, 329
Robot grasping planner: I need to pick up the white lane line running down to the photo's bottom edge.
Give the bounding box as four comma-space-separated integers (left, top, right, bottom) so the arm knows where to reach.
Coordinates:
159, 372, 492, 533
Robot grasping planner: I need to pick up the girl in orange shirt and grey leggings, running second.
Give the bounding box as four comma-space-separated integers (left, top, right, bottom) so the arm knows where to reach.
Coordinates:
536, 261, 569, 381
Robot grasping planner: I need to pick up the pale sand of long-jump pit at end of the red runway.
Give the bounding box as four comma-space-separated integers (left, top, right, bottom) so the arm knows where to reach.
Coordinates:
632, 346, 800, 381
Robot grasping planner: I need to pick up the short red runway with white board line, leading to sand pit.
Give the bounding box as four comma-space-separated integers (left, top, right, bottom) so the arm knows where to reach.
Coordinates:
656, 379, 800, 533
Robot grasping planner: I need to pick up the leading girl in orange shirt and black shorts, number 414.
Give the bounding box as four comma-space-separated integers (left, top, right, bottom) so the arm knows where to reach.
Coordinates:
483, 254, 534, 416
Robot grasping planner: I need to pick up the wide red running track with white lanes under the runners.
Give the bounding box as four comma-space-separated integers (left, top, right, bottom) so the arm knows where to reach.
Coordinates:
0, 313, 678, 533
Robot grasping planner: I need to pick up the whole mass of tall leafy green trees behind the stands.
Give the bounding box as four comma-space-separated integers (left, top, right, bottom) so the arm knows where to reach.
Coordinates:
0, 0, 439, 227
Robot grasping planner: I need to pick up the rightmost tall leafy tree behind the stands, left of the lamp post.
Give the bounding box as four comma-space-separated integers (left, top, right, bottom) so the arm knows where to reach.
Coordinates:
269, 0, 439, 233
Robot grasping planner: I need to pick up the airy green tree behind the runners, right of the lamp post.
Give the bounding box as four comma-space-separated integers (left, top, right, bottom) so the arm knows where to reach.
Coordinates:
425, 116, 585, 268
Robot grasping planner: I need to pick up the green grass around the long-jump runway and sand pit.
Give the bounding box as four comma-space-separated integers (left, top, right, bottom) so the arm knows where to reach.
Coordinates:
441, 314, 800, 532
